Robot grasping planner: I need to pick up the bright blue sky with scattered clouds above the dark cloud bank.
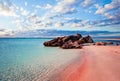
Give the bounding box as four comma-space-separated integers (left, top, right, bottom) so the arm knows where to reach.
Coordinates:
0, 0, 120, 37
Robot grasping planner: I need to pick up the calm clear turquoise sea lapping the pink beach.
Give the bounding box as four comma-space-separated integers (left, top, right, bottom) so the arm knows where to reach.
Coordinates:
0, 38, 119, 81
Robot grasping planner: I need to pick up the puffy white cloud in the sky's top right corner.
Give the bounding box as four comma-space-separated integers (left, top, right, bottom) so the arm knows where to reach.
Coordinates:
95, 0, 120, 19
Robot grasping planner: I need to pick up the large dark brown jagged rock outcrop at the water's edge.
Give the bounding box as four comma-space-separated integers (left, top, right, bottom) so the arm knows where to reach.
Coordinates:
44, 34, 93, 49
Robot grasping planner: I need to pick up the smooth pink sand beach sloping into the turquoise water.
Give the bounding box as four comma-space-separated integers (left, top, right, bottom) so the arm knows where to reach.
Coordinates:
49, 46, 120, 81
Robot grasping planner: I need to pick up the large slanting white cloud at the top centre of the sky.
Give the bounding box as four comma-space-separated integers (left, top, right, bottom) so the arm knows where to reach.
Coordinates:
41, 0, 80, 19
